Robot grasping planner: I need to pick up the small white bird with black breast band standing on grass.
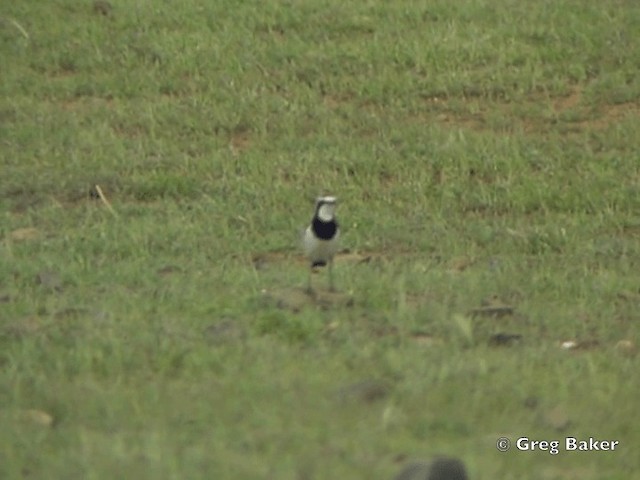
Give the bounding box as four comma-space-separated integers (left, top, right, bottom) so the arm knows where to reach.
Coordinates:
302, 196, 340, 293
